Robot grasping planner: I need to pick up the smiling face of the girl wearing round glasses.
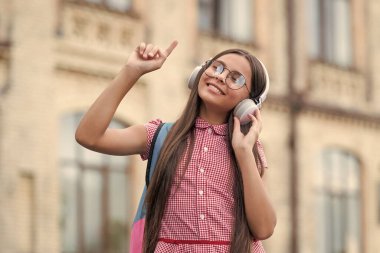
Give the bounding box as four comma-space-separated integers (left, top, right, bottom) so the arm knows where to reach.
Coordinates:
198, 53, 252, 117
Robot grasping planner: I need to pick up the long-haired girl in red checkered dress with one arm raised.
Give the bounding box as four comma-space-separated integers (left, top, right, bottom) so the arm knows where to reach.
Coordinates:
75, 41, 276, 253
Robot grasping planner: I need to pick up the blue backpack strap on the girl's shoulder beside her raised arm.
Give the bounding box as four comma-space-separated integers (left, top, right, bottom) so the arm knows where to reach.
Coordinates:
145, 123, 173, 187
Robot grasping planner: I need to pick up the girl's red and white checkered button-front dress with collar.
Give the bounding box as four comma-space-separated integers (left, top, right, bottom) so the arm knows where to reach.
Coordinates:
141, 118, 267, 253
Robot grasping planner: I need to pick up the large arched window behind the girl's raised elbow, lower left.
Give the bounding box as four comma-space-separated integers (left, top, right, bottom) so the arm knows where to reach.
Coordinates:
60, 114, 132, 253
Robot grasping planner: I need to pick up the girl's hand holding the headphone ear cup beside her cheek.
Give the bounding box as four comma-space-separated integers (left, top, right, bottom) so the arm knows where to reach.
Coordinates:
232, 110, 262, 153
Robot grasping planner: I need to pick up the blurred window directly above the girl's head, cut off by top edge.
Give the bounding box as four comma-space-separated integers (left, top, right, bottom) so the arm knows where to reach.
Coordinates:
198, 0, 254, 42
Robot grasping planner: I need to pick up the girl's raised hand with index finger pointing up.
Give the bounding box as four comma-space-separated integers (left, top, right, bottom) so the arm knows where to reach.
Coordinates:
126, 40, 178, 75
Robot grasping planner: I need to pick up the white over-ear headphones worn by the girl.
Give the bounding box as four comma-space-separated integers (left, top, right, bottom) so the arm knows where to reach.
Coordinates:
187, 58, 269, 125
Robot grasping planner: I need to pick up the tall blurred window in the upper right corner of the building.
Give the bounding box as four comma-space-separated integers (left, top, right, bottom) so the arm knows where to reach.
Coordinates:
307, 0, 353, 67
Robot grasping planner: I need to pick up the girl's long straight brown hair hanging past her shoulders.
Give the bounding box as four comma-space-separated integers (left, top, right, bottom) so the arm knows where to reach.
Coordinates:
143, 49, 266, 253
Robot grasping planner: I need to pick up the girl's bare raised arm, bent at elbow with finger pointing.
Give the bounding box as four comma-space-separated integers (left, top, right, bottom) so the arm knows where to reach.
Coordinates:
75, 41, 177, 155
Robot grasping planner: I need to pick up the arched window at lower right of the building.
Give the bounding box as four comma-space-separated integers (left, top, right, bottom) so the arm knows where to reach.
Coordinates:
317, 149, 361, 253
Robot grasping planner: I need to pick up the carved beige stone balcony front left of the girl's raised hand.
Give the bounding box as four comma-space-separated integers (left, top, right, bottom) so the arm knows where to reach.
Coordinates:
56, 1, 144, 77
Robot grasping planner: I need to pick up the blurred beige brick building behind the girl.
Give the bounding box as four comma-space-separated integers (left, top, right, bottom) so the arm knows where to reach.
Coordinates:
0, 0, 380, 253
